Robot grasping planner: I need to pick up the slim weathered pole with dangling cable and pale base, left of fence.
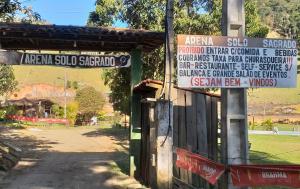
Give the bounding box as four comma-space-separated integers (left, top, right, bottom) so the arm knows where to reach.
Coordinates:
153, 0, 174, 189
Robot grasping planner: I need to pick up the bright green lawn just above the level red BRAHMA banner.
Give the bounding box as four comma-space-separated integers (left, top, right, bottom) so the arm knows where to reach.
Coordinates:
249, 135, 300, 189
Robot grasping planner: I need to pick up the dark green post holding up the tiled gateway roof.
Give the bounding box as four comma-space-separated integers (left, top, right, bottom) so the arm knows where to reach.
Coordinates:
129, 49, 142, 178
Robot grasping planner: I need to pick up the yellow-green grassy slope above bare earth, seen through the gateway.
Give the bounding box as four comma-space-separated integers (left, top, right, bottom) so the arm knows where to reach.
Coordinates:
13, 66, 109, 93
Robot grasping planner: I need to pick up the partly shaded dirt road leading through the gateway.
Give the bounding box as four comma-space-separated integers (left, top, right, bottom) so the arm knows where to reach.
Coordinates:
0, 125, 142, 189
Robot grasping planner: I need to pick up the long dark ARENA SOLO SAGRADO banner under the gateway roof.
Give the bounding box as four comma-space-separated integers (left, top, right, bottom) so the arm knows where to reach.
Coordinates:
0, 51, 130, 68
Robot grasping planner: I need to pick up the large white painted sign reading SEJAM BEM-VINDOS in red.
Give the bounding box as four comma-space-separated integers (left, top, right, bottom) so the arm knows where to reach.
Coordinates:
177, 35, 298, 88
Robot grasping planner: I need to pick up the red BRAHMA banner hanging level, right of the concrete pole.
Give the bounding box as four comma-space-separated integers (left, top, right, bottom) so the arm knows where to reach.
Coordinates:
230, 165, 300, 188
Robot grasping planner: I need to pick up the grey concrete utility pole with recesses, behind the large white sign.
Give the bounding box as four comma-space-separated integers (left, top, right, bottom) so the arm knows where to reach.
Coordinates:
221, 0, 248, 189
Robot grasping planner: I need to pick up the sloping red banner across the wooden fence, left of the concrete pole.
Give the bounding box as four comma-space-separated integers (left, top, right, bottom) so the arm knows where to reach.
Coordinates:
176, 148, 225, 185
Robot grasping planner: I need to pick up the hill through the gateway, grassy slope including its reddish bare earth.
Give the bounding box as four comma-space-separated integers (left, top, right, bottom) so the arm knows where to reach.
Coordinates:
10, 65, 113, 114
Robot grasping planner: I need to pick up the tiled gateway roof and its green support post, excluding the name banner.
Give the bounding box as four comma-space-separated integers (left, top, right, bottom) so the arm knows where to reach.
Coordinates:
0, 23, 165, 180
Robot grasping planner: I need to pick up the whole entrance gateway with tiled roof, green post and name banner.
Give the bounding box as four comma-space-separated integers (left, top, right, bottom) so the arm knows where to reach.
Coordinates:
0, 23, 165, 177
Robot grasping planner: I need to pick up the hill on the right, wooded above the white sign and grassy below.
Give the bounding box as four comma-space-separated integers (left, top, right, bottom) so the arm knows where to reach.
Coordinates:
248, 0, 300, 114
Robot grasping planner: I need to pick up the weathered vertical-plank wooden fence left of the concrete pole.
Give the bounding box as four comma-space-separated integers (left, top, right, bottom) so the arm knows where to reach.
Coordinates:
173, 89, 220, 189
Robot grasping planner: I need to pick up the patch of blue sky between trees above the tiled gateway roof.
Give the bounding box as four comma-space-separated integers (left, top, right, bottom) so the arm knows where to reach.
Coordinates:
23, 0, 96, 26
